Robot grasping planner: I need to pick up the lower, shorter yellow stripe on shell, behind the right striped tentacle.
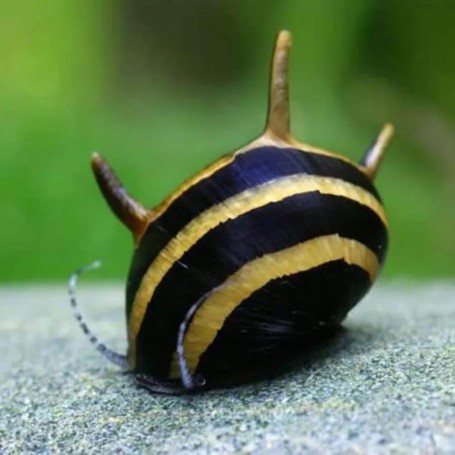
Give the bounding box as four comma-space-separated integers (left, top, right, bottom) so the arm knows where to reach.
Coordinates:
170, 234, 379, 378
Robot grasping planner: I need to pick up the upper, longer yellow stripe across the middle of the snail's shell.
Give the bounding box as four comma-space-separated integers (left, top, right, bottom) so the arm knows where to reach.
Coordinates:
128, 174, 387, 368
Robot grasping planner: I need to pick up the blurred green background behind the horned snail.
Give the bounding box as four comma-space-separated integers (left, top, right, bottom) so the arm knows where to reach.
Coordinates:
0, 0, 455, 282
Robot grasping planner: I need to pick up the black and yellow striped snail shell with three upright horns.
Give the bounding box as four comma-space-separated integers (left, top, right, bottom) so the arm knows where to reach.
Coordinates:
92, 31, 392, 392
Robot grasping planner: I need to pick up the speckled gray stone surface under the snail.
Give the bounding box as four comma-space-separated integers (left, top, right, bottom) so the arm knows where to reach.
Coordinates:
0, 282, 455, 454
